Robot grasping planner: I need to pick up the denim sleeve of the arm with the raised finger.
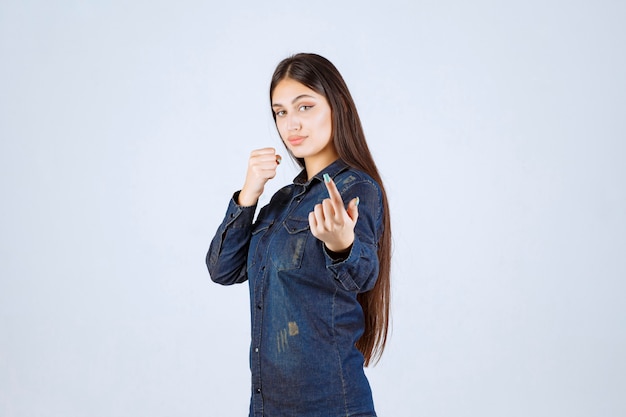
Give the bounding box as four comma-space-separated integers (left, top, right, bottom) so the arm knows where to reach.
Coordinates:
325, 181, 382, 292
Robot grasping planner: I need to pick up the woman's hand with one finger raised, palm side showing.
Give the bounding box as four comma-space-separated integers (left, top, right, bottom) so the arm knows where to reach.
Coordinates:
309, 174, 359, 252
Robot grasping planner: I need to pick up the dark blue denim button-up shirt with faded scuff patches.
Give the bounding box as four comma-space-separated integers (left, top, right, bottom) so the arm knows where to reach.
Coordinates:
206, 160, 382, 417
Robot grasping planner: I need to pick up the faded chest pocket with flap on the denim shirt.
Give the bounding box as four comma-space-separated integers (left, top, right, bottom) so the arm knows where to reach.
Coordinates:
272, 219, 311, 271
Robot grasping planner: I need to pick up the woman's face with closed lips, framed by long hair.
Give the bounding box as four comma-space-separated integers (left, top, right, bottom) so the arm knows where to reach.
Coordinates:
272, 78, 337, 170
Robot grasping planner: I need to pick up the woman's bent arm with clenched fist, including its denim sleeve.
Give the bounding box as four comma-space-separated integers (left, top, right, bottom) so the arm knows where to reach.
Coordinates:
206, 148, 280, 285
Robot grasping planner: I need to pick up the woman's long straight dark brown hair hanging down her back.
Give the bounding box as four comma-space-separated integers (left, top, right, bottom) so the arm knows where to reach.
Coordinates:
270, 53, 391, 366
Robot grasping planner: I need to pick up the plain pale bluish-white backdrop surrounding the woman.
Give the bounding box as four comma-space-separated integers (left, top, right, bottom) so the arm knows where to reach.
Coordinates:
0, 0, 626, 417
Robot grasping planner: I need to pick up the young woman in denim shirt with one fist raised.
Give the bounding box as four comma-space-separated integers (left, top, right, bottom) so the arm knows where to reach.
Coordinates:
206, 54, 391, 417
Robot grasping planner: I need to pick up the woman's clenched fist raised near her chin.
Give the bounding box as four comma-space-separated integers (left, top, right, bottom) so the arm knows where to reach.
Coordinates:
238, 148, 281, 207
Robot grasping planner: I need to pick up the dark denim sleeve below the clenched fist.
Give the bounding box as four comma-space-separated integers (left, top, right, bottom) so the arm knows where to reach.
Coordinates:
206, 191, 256, 285
